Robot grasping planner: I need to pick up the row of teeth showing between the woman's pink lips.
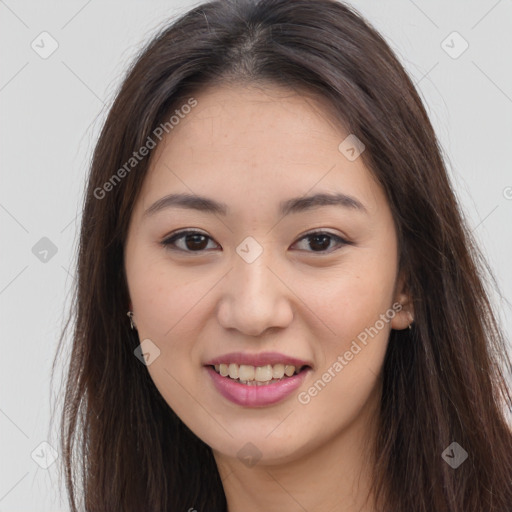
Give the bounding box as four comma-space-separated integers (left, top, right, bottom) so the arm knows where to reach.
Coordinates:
206, 363, 311, 386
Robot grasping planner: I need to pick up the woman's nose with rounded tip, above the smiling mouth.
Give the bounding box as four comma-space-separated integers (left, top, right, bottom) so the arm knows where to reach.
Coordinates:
217, 251, 293, 336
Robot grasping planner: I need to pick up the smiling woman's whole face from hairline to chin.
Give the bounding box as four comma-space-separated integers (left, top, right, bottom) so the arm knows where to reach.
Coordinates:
125, 82, 410, 464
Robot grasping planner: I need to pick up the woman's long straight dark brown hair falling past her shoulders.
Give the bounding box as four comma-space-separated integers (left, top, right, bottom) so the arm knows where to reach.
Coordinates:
53, 0, 512, 512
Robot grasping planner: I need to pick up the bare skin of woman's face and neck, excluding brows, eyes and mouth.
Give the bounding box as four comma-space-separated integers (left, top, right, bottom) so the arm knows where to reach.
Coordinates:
125, 85, 412, 512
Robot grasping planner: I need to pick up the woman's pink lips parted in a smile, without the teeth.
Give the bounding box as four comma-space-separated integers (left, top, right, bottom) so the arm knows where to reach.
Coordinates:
205, 352, 311, 407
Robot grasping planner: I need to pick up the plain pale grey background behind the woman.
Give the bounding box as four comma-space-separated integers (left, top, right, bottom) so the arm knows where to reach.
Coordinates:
0, 0, 512, 512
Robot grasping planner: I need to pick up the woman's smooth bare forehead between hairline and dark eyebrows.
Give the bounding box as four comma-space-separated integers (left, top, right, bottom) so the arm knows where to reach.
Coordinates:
138, 85, 383, 218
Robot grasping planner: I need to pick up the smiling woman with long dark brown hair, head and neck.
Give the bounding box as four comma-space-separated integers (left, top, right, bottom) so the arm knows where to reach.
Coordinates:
56, 0, 512, 512
